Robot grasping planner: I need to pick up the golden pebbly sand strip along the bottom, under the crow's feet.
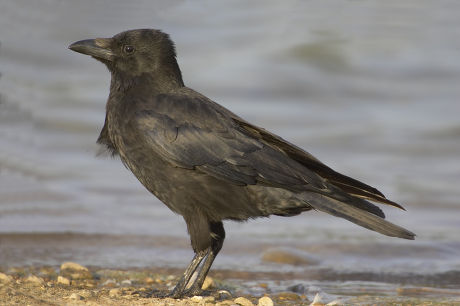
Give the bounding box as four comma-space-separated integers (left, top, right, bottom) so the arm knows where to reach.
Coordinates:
0, 263, 460, 306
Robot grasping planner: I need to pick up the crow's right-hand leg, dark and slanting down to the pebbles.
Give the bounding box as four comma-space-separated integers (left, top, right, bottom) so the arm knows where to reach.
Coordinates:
185, 222, 225, 296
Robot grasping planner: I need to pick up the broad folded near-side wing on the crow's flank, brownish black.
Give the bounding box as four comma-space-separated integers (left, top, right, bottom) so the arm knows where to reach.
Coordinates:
135, 95, 324, 190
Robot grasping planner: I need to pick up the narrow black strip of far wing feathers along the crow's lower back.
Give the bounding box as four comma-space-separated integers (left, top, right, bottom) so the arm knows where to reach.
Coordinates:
233, 116, 404, 210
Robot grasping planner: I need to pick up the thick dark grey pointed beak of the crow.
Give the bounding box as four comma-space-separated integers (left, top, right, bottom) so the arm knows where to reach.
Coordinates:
69, 38, 115, 61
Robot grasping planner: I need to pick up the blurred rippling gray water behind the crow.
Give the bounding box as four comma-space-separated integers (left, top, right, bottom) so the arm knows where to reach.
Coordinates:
0, 0, 460, 298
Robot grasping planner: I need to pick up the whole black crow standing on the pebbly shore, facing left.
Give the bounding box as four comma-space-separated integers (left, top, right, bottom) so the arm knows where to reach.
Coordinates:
69, 29, 415, 298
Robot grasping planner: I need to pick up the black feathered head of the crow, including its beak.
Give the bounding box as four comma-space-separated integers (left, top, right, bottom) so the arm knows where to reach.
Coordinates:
69, 29, 180, 80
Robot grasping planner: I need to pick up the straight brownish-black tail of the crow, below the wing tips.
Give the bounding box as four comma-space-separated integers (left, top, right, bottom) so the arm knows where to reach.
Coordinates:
300, 192, 415, 240
